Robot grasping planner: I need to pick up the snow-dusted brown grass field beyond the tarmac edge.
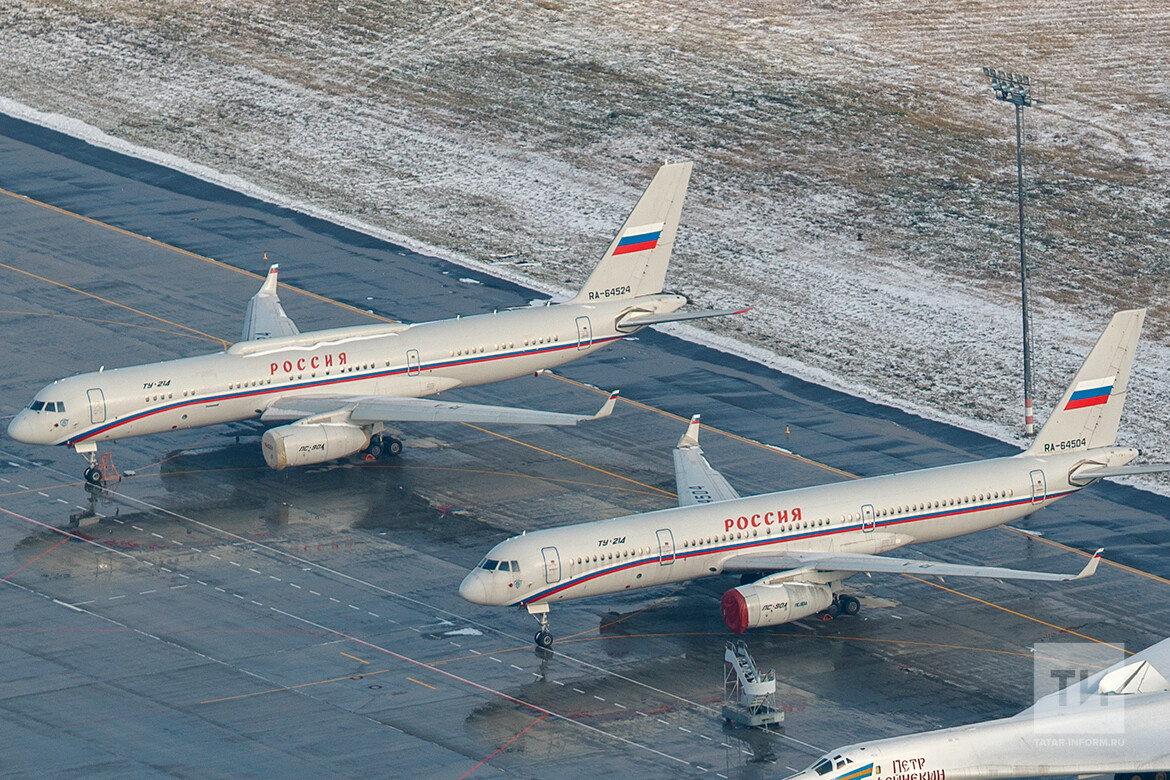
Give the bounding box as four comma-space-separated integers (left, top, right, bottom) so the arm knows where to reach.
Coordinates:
0, 0, 1170, 490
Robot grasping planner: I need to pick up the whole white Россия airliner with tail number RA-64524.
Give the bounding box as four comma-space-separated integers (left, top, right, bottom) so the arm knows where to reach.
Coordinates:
8, 163, 744, 483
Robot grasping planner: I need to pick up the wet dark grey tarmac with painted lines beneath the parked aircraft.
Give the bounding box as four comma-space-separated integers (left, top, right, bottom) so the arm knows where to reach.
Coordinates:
0, 117, 1170, 778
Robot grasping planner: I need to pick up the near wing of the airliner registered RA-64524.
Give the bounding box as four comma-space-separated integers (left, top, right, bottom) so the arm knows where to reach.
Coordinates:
260, 393, 618, 426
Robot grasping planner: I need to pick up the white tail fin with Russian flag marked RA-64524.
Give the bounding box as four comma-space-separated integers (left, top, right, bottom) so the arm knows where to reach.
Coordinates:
570, 163, 693, 303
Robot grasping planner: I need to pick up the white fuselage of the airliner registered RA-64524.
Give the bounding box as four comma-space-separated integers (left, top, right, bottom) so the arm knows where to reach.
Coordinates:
8, 295, 684, 449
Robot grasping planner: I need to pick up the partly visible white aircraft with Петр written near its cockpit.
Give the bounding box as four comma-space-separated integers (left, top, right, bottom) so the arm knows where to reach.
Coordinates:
789, 640, 1170, 780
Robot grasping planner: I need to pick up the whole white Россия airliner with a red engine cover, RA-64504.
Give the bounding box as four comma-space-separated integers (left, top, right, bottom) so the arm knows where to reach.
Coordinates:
459, 309, 1170, 647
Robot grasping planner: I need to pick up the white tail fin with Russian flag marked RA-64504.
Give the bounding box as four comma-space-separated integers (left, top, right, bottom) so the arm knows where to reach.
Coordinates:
1026, 309, 1145, 455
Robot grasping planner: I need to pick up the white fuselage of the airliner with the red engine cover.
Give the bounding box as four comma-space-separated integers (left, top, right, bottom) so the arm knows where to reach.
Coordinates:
460, 447, 1137, 606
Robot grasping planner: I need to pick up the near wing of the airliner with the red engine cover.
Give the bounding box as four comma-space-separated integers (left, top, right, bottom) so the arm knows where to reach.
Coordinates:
723, 550, 1104, 582
